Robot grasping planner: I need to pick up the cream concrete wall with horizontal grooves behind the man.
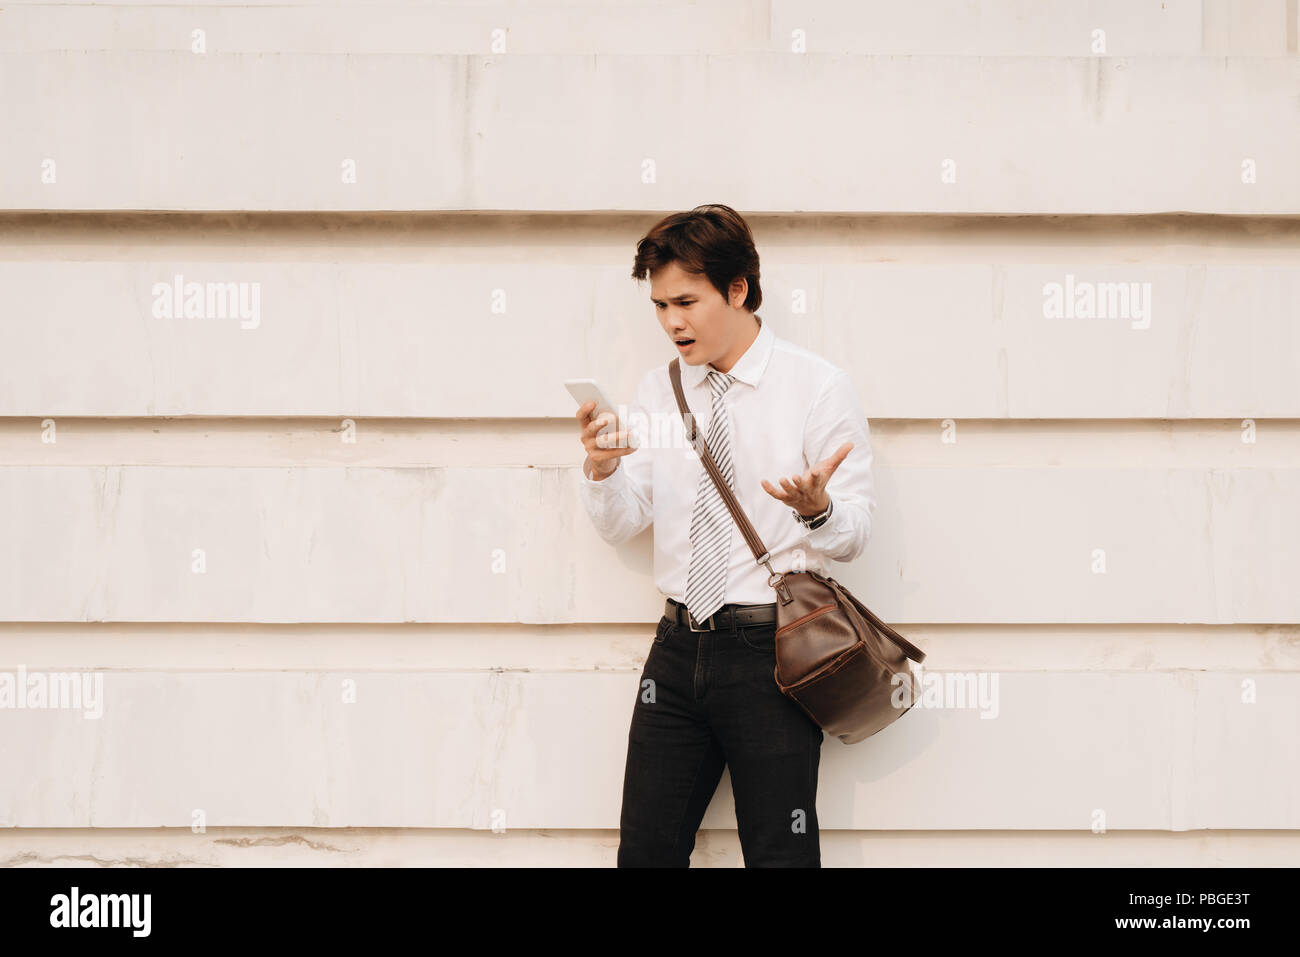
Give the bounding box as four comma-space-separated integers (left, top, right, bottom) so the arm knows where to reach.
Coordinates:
0, 0, 1300, 866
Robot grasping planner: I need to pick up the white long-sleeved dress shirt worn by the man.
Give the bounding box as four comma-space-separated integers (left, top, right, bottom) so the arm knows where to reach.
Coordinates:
579, 319, 876, 605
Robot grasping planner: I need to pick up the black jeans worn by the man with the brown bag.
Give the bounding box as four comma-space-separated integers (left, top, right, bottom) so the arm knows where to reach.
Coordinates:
619, 618, 823, 867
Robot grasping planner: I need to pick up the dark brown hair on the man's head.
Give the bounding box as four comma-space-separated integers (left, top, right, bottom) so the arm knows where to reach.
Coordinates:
632, 204, 763, 312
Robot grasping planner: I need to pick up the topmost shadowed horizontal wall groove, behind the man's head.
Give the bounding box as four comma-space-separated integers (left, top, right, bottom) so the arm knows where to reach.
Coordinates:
0, 209, 1300, 263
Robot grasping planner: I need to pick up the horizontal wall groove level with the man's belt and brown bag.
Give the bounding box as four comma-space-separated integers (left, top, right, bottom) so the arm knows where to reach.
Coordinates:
0, 622, 1300, 674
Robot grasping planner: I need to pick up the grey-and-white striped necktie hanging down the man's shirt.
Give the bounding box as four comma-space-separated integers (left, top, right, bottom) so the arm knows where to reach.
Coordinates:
686, 369, 736, 624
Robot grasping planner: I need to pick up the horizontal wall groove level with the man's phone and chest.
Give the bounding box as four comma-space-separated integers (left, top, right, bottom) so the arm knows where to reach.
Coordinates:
0, 418, 1300, 469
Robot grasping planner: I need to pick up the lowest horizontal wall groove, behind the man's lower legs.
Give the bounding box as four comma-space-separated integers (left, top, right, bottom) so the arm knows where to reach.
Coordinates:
0, 827, 1300, 867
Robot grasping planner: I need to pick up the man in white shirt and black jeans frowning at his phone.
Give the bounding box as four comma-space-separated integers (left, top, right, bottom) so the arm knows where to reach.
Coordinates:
577, 205, 875, 867
